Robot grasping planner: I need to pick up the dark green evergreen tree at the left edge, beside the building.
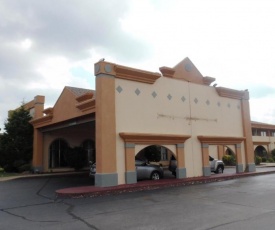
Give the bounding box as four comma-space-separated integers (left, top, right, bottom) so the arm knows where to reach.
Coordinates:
0, 105, 33, 171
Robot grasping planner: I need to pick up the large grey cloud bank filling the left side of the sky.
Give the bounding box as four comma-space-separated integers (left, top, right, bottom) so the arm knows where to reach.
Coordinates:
0, 0, 155, 129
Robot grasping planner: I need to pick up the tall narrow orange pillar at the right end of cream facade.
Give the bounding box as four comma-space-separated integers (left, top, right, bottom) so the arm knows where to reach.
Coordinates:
241, 91, 256, 172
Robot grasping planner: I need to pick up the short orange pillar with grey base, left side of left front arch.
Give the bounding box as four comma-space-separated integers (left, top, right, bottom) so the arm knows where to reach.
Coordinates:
125, 143, 137, 184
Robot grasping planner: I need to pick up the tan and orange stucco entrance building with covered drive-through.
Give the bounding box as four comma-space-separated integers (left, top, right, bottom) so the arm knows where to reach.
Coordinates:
27, 58, 255, 187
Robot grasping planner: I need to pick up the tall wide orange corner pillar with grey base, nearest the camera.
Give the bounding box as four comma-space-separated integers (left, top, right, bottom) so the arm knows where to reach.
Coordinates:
95, 61, 118, 187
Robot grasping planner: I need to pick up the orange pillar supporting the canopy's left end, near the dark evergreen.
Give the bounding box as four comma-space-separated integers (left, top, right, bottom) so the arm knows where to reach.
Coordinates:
32, 128, 44, 173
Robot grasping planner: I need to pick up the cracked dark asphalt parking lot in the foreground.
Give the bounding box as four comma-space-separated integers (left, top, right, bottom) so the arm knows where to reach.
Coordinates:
0, 166, 275, 230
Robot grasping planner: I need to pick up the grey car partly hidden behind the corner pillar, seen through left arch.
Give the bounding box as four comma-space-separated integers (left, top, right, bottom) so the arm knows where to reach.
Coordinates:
89, 159, 164, 180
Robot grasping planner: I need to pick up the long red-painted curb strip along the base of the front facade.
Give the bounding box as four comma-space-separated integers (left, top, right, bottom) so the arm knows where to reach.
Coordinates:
56, 167, 275, 198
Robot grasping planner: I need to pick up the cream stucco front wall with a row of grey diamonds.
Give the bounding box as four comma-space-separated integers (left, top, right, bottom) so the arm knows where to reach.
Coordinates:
115, 77, 243, 183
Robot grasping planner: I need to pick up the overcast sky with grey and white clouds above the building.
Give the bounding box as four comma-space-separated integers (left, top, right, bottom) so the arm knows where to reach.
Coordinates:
0, 0, 275, 132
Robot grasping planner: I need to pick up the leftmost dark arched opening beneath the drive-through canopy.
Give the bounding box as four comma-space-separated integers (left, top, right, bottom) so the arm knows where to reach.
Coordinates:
49, 139, 69, 168
